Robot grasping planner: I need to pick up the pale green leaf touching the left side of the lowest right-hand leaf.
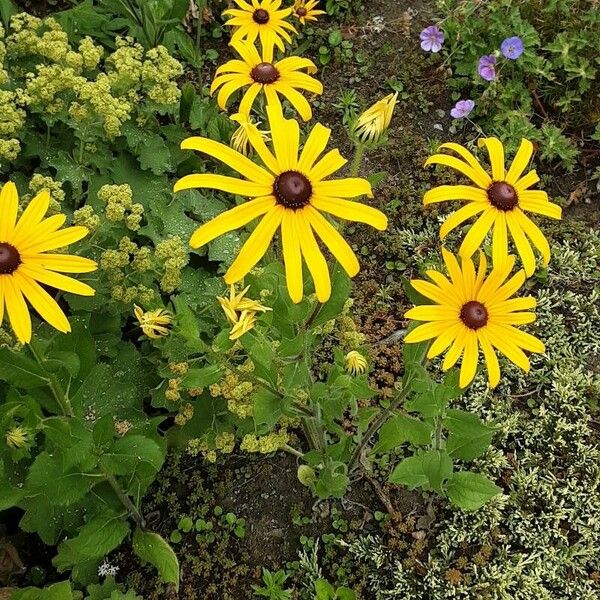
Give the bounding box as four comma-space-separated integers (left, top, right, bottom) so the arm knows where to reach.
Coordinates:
389, 450, 452, 492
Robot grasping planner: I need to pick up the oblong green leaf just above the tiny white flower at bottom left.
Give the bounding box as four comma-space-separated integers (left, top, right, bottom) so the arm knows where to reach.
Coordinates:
52, 513, 129, 572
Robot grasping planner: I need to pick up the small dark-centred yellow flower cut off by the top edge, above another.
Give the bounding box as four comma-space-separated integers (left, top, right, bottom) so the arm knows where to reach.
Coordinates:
223, 0, 297, 53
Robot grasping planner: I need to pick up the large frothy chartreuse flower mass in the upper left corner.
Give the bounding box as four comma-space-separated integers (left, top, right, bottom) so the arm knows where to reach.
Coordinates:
0, 13, 183, 160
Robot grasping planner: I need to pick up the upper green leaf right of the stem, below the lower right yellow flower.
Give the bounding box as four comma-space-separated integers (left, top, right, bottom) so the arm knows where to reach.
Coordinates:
444, 409, 494, 460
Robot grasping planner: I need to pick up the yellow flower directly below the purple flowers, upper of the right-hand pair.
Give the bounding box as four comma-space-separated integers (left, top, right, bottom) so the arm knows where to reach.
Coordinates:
423, 138, 562, 277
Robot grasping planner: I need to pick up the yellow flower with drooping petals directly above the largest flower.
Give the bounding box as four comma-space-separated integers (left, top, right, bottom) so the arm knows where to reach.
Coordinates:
210, 41, 323, 121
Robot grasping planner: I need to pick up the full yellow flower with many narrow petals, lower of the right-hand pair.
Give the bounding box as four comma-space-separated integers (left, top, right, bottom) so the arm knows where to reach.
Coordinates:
405, 250, 545, 387
